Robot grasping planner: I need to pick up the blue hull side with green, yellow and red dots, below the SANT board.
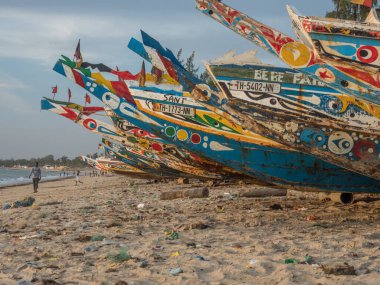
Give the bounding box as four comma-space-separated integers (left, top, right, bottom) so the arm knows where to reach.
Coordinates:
54, 58, 379, 192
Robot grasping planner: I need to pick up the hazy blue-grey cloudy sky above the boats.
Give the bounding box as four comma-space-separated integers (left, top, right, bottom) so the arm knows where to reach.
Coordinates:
0, 0, 333, 159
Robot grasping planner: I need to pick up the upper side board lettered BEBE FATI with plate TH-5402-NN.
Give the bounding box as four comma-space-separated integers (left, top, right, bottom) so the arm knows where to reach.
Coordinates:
207, 61, 380, 130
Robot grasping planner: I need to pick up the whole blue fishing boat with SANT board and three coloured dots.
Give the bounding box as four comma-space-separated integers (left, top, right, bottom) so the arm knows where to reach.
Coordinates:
54, 56, 379, 192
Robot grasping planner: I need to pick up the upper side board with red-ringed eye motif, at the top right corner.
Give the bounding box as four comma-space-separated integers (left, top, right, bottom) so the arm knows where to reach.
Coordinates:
287, 6, 380, 69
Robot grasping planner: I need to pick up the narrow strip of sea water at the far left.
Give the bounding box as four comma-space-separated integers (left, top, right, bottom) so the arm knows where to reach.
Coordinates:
0, 168, 72, 187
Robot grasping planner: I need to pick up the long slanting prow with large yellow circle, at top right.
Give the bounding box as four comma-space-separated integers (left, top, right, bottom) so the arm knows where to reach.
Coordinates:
196, 0, 380, 107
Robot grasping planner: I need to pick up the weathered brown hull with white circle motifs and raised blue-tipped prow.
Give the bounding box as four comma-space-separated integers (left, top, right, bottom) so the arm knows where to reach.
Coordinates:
129, 32, 380, 180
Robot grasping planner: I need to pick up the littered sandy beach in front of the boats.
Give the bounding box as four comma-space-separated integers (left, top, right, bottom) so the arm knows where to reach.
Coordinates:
0, 176, 380, 285
